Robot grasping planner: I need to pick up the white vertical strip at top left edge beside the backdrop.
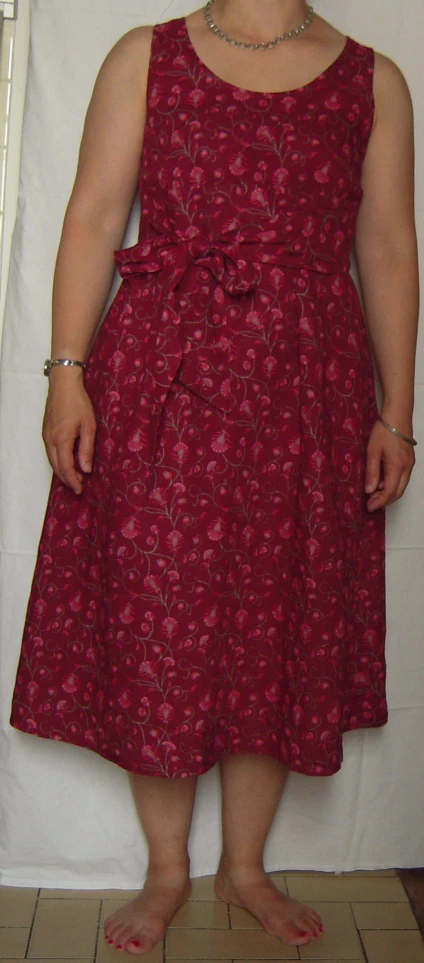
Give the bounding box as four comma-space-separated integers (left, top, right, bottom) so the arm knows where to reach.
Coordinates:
0, 0, 30, 342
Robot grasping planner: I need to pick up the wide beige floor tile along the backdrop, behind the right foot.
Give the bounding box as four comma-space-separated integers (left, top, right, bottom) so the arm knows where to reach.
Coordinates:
287, 876, 408, 903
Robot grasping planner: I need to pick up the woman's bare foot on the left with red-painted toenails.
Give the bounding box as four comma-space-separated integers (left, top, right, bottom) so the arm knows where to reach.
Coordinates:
104, 868, 192, 955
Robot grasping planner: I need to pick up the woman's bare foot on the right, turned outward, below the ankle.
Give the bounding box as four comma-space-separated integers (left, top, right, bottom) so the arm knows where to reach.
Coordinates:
215, 860, 322, 946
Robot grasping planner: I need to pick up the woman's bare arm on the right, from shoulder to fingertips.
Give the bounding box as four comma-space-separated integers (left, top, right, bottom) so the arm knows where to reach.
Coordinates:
354, 54, 419, 509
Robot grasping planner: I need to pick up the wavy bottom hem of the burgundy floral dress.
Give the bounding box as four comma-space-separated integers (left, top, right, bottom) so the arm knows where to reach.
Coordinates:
9, 714, 389, 780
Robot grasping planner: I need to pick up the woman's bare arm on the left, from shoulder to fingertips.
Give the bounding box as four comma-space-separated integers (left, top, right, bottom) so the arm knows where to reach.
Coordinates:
42, 26, 152, 494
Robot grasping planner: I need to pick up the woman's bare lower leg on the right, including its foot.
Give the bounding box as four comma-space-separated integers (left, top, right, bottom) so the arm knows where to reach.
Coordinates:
215, 753, 322, 945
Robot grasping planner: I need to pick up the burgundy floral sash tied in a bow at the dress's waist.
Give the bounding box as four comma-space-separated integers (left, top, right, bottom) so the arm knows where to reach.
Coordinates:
114, 234, 350, 460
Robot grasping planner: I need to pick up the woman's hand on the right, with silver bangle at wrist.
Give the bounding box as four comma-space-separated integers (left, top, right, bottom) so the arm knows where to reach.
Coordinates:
365, 411, 415, 511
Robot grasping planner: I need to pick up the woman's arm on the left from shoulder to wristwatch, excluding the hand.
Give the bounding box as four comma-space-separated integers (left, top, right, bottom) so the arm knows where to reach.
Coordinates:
49, 27, 152, 377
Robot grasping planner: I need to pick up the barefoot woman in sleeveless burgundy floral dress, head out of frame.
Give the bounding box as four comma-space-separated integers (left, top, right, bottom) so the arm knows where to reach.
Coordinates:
11, 0, 418, 954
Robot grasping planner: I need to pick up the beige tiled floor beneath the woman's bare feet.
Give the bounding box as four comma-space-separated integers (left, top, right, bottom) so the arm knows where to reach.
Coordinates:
0, 870, 424, 963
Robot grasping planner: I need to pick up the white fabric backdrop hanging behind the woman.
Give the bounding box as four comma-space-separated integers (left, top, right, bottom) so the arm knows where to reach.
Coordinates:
0, 0, 424, 889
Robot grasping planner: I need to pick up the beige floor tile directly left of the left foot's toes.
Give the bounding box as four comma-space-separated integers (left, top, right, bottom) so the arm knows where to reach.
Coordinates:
28, 899, 100, 959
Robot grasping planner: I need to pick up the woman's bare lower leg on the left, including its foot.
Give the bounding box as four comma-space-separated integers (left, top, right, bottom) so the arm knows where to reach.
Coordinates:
104, 773, 197, 954
